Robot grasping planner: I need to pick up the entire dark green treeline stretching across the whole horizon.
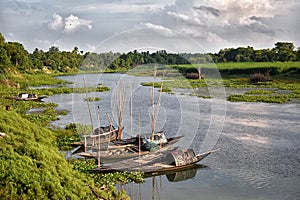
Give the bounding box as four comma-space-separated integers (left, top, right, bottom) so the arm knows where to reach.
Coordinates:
0, 33, 300, 74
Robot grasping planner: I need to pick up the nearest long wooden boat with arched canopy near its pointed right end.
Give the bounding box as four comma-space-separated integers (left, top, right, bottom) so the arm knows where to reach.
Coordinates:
95, 149, 216, 175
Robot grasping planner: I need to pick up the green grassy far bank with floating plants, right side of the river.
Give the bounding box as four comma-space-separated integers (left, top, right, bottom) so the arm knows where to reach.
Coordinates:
135, 62, 300, 103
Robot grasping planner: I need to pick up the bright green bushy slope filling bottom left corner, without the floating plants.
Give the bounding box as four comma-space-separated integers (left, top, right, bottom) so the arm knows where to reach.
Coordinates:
0, 109, 94, 199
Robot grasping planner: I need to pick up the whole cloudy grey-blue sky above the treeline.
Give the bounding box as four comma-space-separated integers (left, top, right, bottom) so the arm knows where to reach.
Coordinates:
0, 0, 300, 53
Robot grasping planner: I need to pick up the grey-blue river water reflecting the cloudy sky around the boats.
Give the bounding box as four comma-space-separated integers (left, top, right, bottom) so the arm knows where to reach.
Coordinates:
45, 74, 300, 200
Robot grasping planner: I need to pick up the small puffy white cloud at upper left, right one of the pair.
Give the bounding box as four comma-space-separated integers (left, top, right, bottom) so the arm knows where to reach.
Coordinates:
64, 14, 92, 33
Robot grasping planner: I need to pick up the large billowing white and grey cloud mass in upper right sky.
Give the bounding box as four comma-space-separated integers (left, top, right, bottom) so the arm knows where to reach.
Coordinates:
138, 0, 290, 51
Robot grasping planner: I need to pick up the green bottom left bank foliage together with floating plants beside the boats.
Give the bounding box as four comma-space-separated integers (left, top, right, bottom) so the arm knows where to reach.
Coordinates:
0, 109, 143, 199
